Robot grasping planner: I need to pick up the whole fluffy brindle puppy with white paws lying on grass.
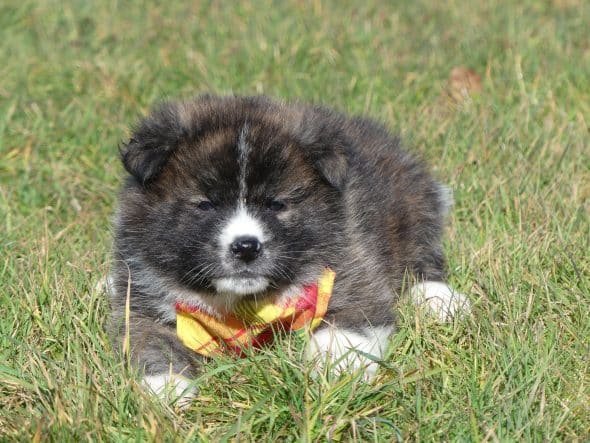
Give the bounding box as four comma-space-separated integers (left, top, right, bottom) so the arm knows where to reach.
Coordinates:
110, 95, 467, 399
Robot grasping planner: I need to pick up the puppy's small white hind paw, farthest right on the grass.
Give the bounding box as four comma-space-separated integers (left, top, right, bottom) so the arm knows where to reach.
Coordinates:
410, 281, 471, 322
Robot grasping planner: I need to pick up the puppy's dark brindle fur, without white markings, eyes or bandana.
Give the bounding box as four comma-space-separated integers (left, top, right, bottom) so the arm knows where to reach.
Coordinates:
111, 96, 446, 376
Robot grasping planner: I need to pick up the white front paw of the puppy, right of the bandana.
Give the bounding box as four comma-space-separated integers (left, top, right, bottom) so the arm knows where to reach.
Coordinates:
305, 327, 393, 381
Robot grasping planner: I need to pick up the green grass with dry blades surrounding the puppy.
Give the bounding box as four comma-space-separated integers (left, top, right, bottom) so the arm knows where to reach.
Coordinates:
0, 0, 590, 441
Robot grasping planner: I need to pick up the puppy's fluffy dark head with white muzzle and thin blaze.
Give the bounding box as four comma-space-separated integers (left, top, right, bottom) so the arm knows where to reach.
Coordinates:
116, 97, 347, 299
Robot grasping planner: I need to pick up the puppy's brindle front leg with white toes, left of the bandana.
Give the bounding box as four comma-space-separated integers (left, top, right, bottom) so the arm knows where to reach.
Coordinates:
111, 316, 199, 405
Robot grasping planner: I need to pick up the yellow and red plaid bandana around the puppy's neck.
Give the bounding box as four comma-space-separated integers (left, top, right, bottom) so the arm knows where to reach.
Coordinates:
176, 269, 336, 356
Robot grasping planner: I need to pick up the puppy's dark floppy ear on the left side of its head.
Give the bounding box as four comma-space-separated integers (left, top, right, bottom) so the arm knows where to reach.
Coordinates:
120, 103, 185, 184
